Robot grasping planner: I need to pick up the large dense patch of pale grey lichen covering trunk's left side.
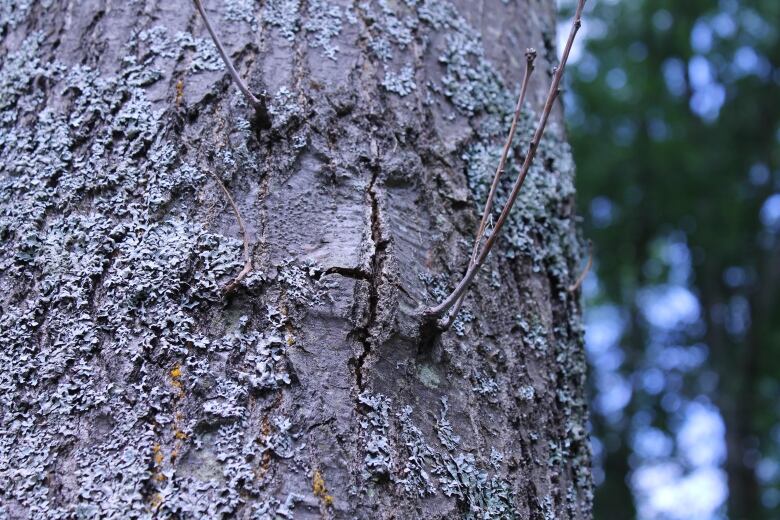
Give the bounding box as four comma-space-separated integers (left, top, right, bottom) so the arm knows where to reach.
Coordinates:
0, 29, 294, 518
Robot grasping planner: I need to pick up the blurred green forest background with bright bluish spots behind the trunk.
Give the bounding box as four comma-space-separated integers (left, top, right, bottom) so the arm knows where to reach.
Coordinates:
561, 0, 780, 520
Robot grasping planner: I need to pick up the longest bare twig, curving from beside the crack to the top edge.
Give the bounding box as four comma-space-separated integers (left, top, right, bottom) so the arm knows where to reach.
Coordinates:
423, 0, 585, 327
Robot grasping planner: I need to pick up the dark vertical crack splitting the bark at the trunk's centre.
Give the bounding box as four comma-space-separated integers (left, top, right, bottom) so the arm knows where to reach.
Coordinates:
352, 169, 387, 392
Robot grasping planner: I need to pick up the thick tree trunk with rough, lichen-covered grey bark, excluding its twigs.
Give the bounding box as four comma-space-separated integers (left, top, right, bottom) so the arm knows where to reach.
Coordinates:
0, 0, 591, 519
